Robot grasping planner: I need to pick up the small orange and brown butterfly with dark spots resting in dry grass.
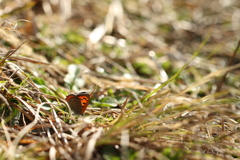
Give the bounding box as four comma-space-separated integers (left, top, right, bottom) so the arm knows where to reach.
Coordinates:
65, 89, 95, 115
